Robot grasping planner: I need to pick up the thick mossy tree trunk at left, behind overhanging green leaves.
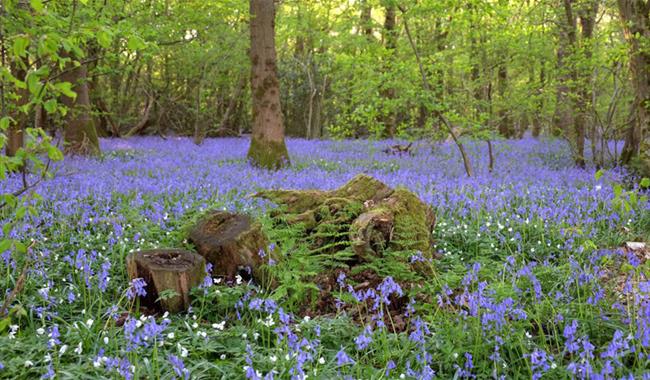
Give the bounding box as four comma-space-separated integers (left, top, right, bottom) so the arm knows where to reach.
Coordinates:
61, 54, 99, 155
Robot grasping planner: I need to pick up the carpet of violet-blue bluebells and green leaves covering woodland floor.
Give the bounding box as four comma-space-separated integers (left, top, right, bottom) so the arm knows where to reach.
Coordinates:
0, 138, 650, 379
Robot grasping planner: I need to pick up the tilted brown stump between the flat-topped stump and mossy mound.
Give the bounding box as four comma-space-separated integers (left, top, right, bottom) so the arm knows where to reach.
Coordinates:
189, 211, 272, 283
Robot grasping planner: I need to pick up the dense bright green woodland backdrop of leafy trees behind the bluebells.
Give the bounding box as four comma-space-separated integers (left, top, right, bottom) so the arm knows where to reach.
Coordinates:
0, 0, 650, 173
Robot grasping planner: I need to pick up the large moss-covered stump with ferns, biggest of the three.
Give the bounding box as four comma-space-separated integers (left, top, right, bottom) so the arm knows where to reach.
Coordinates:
256, 174, 435, 275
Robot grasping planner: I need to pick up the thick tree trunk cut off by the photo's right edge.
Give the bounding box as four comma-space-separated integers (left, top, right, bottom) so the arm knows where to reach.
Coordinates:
618, 0, 650, 169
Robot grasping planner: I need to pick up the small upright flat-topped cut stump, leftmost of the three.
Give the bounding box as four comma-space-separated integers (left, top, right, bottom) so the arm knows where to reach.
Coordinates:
126, 249, 205, 313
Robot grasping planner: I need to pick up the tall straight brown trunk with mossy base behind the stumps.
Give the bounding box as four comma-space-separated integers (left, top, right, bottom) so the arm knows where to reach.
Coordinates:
248, 0, 289, 169
